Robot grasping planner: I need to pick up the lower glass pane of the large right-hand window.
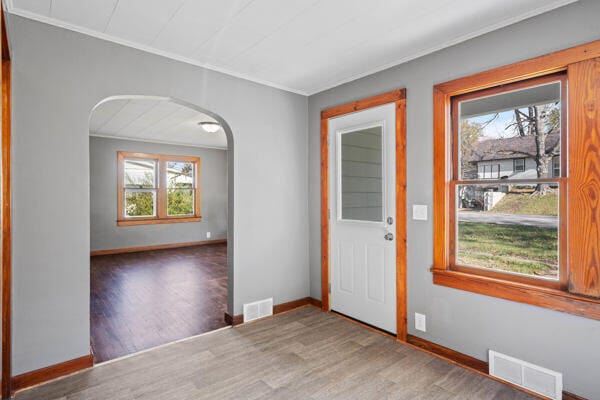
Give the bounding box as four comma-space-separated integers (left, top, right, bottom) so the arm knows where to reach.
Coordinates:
456, 182, 559, 280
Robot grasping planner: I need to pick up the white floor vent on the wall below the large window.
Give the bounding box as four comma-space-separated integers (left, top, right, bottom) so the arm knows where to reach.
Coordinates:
489, 350, 562, 400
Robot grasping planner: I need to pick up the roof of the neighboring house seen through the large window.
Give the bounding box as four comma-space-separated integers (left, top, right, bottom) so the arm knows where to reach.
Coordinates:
469, 132, 560, 162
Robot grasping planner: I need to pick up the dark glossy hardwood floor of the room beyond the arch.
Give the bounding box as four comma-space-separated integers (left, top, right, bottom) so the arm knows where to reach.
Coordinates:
91, 244, 227, 363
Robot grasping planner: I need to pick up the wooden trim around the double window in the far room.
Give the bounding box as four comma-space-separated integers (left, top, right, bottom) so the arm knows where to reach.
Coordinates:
117, 151, 202, 226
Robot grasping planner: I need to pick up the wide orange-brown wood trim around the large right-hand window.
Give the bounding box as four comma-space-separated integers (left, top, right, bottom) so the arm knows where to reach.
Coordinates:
431, 41, 600, 320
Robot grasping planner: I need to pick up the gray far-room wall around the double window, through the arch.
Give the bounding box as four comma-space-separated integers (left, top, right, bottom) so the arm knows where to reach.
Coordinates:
90, 137, 227, 250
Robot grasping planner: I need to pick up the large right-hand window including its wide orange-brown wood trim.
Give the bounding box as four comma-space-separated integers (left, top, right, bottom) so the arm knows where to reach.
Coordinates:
432, 42, 600, 319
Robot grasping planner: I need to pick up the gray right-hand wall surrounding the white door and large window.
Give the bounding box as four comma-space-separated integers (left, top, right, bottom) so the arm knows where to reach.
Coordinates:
309, 1, 600, 399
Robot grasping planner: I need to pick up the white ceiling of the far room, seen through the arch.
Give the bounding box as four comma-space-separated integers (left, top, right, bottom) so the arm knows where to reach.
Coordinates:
90, 98, 227, 149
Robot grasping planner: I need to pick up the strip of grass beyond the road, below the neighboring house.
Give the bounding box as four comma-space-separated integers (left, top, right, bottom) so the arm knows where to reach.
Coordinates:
489, 193, 558, 215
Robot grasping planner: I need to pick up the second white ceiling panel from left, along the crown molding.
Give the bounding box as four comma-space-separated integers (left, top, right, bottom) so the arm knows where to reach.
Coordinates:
50, 0, 118, 32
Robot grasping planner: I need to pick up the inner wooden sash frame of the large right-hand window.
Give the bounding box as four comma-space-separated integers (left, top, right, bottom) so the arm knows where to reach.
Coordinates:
446, 73, 568, 290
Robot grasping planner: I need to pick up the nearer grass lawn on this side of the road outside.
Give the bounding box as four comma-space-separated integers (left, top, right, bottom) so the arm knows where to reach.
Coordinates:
456, 222, 558, 278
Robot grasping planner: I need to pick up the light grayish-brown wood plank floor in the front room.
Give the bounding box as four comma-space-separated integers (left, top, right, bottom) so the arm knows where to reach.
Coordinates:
16, 307, 531, 400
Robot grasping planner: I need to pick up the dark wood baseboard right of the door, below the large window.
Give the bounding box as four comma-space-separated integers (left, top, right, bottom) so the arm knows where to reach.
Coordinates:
406, 335, 587, 400
